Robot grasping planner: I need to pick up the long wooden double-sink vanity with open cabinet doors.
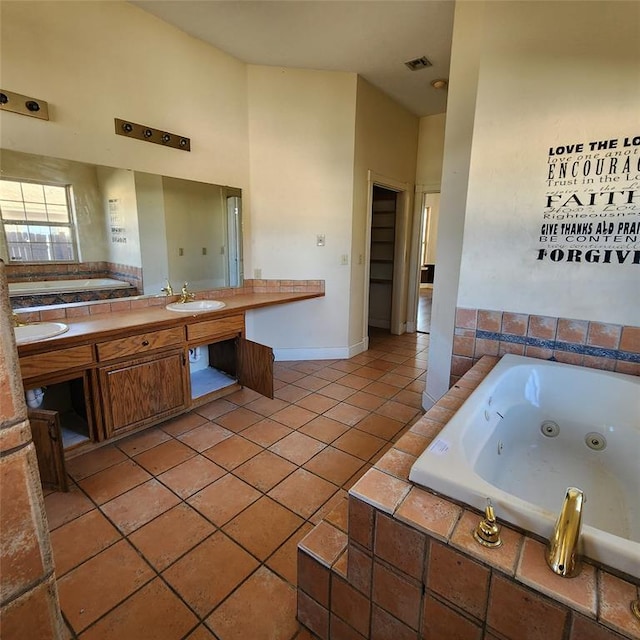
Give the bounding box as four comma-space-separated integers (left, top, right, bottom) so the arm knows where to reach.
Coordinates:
18, 292, 324, 490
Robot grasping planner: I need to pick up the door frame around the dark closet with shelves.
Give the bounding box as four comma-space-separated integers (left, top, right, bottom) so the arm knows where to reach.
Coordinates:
362, 170, 412, 338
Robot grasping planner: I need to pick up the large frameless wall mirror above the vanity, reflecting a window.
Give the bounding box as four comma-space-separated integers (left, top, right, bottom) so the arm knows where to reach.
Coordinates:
0, 149, 243, 308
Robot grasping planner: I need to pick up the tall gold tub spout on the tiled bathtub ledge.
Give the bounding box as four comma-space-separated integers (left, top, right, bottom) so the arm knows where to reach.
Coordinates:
547, 487, 586, 578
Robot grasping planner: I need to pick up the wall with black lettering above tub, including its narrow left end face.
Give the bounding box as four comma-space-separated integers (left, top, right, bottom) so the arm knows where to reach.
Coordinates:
427, 2, 640, 399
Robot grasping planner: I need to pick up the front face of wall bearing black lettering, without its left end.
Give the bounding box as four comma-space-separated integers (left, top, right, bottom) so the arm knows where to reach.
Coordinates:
458, 2, 640, 324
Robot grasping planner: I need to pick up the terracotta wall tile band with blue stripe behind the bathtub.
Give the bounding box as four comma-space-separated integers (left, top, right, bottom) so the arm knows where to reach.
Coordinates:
451, 308, 640, 382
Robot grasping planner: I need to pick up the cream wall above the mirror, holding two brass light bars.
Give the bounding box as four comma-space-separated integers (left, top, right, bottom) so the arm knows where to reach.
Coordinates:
0, 0, 249, 210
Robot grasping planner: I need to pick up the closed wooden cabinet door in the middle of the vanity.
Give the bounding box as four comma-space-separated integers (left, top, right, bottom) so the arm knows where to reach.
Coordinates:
99, 349, 187, 436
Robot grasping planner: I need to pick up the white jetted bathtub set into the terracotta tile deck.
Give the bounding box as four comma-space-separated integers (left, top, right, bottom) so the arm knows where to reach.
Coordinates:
409, 355, 640, 577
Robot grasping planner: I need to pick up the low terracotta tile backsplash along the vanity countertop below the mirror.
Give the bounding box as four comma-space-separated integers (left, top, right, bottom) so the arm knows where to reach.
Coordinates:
11, 280, 324, 322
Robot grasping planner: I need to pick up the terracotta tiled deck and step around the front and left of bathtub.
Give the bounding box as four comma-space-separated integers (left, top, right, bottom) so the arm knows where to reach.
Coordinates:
298, 357, 640, 640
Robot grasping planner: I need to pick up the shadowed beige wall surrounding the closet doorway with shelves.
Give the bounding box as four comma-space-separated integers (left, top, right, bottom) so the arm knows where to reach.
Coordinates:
349, 78, 418, 346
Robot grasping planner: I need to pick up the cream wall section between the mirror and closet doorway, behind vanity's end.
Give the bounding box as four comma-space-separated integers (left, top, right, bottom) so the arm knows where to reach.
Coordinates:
245, 66, 356, 359
